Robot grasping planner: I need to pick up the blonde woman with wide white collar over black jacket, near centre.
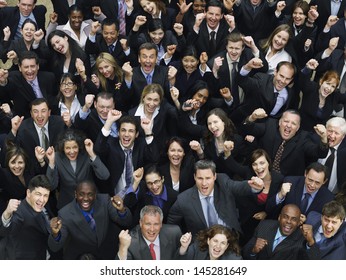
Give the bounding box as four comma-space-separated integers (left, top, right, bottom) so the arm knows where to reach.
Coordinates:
129, 84, 177, 151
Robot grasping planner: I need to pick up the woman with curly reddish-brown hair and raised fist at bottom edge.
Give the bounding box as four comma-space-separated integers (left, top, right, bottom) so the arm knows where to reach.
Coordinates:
179, 225, 243, 260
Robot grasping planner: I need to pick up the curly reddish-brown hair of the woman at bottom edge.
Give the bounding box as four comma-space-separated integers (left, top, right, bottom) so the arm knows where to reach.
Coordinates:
196, 225, 240, 255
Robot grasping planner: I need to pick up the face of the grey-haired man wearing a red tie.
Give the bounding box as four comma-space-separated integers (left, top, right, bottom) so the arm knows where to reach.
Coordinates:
139, 213, 162, 242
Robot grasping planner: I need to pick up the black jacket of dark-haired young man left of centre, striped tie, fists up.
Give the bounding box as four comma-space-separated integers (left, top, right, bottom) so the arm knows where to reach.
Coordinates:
94, 132, 159, 196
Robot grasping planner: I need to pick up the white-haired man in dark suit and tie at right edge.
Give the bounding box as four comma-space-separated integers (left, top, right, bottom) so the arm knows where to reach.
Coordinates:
318, 117, 346, 194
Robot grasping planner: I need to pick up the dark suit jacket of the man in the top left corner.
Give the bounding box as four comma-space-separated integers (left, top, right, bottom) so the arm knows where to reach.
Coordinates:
0, 5, 47, 40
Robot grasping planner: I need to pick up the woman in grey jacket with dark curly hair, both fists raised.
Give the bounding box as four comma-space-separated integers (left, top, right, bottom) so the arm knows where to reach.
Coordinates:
46, 129, 110, 209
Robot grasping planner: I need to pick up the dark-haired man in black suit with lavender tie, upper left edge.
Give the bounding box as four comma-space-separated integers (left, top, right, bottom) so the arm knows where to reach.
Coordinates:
0, 51, 57, 118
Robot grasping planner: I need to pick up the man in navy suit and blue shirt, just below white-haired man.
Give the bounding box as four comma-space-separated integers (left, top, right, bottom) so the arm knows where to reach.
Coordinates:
266, 162, 334, 220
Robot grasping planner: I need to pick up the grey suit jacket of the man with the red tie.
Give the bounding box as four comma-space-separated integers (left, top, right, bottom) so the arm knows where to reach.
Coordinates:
119, 224, 181, 260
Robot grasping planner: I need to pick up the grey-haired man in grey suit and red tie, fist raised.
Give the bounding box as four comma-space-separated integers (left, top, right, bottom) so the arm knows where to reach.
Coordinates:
117, 205, 181, 260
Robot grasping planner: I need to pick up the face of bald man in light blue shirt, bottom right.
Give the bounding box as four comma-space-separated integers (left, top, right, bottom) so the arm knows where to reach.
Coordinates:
278, 206, 300, 236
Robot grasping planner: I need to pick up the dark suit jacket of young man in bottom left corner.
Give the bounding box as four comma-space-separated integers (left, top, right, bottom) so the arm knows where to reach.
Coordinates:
0, 199, 49, 260
